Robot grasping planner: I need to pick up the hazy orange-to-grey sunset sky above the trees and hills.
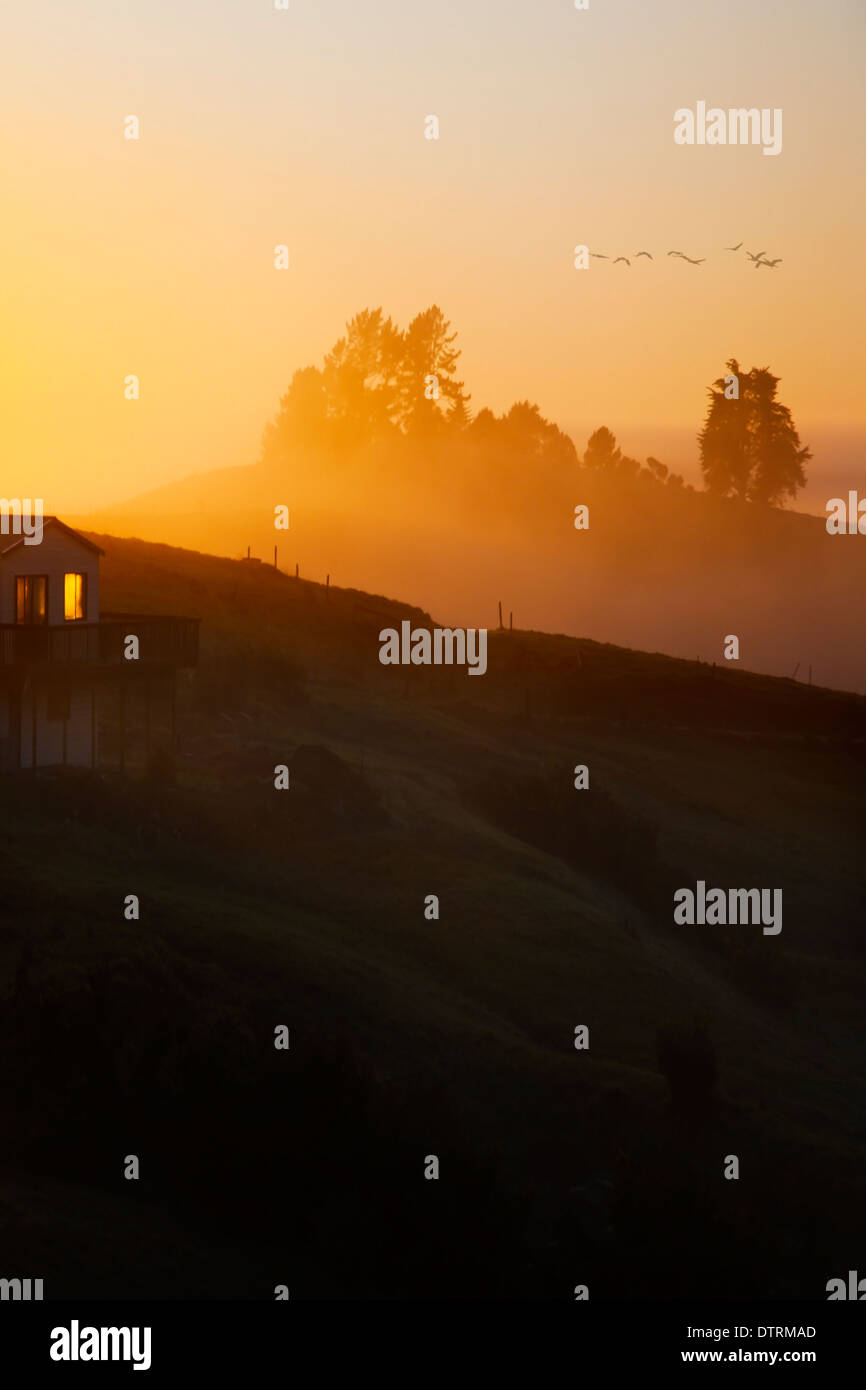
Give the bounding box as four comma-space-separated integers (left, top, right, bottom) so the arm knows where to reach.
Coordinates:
0, 0, 866, 512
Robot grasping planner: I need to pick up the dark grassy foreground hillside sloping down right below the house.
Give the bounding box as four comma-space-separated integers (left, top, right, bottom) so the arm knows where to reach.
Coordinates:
0, 536, 866, 1298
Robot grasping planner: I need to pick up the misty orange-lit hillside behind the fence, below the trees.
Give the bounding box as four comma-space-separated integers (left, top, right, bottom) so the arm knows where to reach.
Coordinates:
78, 448, 866, 694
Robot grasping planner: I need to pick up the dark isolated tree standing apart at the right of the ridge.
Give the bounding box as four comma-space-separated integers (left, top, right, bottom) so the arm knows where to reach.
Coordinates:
698, 357, 812, 506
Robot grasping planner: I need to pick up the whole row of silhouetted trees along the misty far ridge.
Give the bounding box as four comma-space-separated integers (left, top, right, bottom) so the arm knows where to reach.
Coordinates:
263, 304, 812, 506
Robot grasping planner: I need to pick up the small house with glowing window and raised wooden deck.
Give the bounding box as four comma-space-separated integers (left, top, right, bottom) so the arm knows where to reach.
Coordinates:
0, 517, 199, 771
